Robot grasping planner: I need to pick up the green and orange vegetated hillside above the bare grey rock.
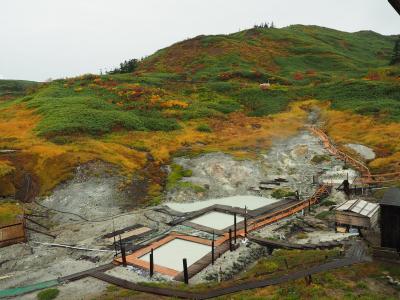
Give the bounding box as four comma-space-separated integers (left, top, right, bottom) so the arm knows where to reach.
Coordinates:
0, 25, 400, 202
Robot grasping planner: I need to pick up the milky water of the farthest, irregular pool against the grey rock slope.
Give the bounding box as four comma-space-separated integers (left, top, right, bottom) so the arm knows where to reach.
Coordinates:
166, 196, 279, 212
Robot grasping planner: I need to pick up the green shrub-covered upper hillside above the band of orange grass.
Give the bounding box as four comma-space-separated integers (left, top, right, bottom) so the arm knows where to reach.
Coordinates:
0, 25, 400, 141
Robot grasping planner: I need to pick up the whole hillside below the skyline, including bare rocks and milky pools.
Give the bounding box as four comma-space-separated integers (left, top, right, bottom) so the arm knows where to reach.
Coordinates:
0, 25, 400, 299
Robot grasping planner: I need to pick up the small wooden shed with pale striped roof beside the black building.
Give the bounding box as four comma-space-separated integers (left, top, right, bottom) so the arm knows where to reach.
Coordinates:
335, 199, 379, 229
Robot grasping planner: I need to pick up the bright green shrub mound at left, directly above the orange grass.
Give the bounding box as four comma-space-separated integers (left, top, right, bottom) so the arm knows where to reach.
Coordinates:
22, 83, 179, 136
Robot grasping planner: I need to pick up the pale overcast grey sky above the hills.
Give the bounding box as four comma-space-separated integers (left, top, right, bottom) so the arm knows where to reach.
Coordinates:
0, 0, 400, 80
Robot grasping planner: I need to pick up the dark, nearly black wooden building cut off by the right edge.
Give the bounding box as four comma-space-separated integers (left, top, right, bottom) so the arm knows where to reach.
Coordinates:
380, 188, 400, 251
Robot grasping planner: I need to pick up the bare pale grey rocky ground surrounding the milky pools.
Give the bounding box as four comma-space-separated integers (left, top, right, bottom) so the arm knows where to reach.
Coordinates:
0, 123, 376, 299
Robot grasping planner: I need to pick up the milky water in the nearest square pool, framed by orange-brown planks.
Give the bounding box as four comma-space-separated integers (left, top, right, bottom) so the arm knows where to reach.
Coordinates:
140, 239, 211, 272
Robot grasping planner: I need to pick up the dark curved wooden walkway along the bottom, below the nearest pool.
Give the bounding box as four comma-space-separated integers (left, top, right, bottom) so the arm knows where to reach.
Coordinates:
90, 258, 362, 300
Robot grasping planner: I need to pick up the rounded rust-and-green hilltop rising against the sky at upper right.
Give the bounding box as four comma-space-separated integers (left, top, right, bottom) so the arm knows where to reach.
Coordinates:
140, 25, 395, 79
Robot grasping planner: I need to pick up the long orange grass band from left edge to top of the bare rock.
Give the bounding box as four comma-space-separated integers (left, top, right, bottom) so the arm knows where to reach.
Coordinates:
0, 102, 311, 195
